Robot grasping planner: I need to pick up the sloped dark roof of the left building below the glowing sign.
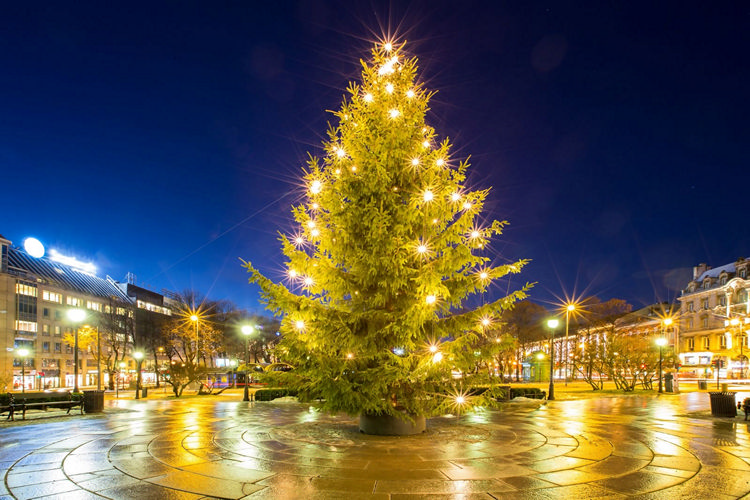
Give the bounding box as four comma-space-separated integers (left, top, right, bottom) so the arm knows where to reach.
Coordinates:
8, 247, 128, 300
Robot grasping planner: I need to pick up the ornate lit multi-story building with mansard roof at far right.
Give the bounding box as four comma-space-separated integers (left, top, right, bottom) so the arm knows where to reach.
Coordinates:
678, 258, 750, 378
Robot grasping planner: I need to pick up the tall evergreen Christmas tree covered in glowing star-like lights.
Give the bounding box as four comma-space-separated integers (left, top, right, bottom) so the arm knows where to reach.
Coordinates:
245, 43, 528, 428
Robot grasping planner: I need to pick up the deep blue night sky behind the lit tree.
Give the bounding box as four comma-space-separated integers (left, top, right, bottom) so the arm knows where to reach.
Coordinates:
0, 1, 750, 310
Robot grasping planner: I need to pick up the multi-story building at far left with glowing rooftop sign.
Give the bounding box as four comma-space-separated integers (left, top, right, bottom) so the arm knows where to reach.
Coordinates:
0, 236, 171, 392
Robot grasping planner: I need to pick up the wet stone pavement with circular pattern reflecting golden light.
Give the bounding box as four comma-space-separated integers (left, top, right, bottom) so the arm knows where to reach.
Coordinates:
0, 393, 750, 500
